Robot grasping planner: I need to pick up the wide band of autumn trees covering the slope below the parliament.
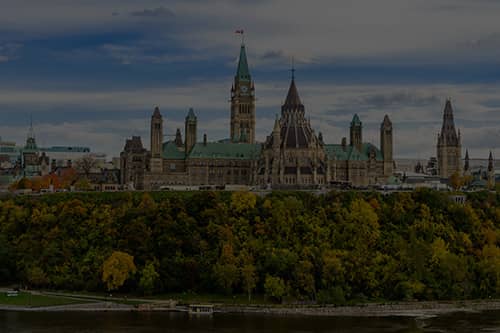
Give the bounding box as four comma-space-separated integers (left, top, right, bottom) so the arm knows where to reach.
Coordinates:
0, 190, 500, 303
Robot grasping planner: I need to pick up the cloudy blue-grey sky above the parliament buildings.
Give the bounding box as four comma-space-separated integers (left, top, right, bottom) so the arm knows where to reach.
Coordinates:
0, 0, 500, 159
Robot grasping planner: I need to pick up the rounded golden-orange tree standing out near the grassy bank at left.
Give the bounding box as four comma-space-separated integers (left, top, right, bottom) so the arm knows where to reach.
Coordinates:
102, 251, 136, 291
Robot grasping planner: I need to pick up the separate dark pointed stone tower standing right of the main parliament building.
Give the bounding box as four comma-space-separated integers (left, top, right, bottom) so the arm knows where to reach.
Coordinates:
437, 99, 462, 178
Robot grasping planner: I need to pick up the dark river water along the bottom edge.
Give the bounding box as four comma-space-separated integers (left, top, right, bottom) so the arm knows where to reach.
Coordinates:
0, 311, 500, 333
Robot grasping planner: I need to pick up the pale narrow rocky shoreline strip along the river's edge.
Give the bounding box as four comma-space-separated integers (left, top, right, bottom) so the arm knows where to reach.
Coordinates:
0, 300, 500, 318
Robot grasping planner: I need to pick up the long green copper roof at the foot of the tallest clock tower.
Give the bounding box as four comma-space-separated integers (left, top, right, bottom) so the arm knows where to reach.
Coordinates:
189, 142, 261, 160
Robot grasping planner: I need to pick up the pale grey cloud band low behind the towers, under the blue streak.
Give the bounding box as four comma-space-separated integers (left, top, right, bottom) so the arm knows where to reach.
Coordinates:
0, 77, 500, 158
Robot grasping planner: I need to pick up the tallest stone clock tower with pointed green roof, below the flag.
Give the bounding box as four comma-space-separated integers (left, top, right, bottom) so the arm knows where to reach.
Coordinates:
230, 44, 255, 143
